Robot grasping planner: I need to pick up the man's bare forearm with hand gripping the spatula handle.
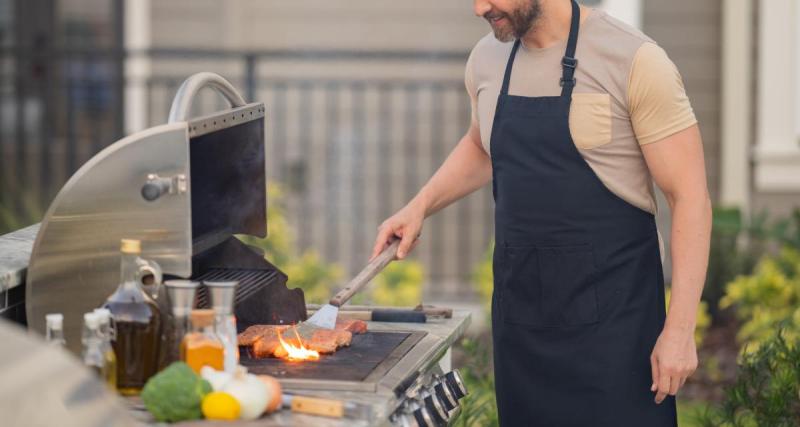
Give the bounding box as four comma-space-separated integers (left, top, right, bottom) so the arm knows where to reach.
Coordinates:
372, 119, 492, 259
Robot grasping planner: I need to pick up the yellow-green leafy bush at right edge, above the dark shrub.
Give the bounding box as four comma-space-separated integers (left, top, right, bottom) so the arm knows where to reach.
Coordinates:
720, 246, 800, 351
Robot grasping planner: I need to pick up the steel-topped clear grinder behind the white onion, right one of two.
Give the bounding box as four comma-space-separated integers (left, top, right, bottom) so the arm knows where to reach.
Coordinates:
203, 280, 239, 373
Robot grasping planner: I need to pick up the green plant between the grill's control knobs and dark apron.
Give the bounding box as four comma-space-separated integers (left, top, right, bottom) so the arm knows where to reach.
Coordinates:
454, 338, 499, 427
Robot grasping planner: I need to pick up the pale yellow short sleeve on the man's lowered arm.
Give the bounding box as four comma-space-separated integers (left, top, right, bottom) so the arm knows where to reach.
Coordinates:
628, 42, 697, 145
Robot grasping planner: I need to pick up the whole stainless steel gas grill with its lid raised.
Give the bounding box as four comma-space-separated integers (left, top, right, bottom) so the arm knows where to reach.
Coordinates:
17, 73, 469, 426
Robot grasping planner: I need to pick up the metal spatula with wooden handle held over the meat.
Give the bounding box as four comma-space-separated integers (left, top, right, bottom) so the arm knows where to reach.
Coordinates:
290, 239, 400, 340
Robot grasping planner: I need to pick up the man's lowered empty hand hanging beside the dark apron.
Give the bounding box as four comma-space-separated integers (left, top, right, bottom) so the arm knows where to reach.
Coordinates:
650, 328, 697, 403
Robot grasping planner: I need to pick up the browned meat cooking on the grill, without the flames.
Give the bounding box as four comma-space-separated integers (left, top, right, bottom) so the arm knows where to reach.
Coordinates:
238, 319, 367, 358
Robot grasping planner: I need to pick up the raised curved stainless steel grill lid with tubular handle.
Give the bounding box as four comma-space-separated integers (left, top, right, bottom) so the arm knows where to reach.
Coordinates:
26, 73, 266, 353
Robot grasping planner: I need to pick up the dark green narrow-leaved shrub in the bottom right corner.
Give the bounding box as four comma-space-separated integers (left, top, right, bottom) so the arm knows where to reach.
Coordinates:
697, 331, 800, 427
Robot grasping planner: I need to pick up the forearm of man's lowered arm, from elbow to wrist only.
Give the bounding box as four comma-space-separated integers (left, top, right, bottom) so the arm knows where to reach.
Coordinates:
665, 194, 711, 333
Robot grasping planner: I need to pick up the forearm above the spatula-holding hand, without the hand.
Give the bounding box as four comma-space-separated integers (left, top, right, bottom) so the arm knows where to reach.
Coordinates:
409, 132, 492, 217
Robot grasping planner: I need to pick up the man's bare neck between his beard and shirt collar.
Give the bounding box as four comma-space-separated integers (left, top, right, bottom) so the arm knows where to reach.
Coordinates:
522, 0, 588, 49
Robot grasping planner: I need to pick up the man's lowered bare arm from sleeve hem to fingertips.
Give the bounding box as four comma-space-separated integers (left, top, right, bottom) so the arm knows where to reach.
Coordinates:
642, 125, 711, 403
